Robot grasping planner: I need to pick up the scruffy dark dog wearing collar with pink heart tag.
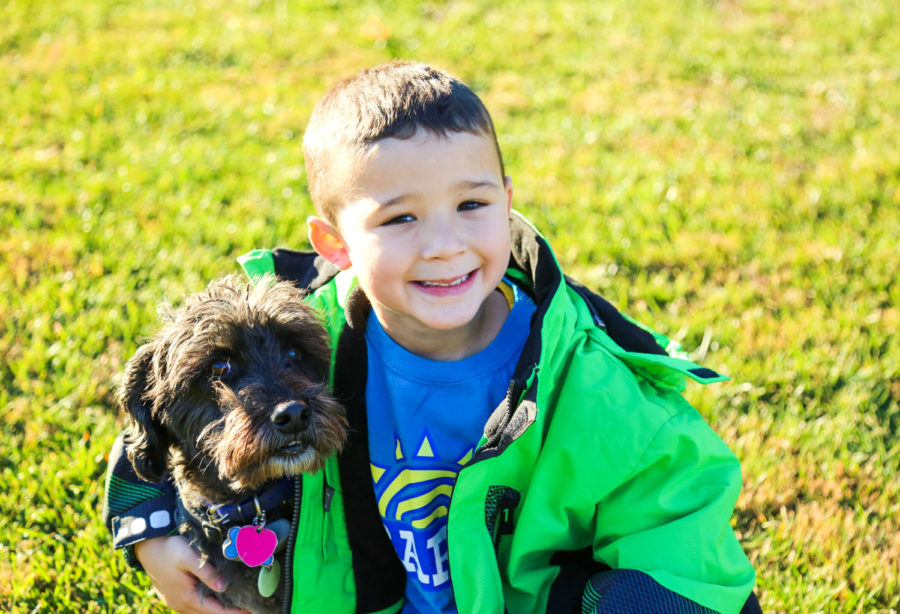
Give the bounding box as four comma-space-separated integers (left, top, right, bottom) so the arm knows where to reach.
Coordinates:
119, 276, 347, 613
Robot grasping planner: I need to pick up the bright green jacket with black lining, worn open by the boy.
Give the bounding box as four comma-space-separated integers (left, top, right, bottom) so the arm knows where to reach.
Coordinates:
240, 215, 755, 614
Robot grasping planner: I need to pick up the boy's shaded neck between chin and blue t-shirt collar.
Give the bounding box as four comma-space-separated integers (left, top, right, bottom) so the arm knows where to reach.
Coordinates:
373, 290, 510, 362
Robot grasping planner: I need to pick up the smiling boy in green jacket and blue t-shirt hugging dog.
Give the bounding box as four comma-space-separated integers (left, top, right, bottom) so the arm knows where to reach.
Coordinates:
108, 62, 755, 613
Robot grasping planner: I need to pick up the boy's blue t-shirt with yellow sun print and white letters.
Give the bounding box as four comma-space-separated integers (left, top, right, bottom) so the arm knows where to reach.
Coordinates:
366, 284, 535, 614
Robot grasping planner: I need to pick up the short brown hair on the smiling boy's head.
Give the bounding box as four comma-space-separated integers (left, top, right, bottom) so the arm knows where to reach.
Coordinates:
303, 61, 505, 223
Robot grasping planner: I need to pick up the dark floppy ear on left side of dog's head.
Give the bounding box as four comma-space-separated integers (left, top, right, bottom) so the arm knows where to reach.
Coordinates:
119, 342, 169, 482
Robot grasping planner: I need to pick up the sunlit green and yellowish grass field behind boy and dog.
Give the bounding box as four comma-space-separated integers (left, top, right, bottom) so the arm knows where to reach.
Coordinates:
0, 0, 900, 613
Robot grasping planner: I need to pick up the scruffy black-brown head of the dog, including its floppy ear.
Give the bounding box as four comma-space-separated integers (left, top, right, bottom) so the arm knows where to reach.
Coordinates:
119, 276, 347, 492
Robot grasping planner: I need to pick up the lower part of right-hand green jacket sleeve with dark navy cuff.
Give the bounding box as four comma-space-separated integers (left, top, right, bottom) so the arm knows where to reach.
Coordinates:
582, 404, 755, 614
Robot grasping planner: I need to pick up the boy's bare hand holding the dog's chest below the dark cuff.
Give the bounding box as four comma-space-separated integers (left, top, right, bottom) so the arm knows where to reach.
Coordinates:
134, 535, 248, 614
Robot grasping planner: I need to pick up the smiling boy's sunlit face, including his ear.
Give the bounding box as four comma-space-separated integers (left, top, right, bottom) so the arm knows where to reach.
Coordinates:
310, 130, 512, 353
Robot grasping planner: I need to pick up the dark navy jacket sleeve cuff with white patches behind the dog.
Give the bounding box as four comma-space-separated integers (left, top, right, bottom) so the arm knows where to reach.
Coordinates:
103, 433, 176, 567
